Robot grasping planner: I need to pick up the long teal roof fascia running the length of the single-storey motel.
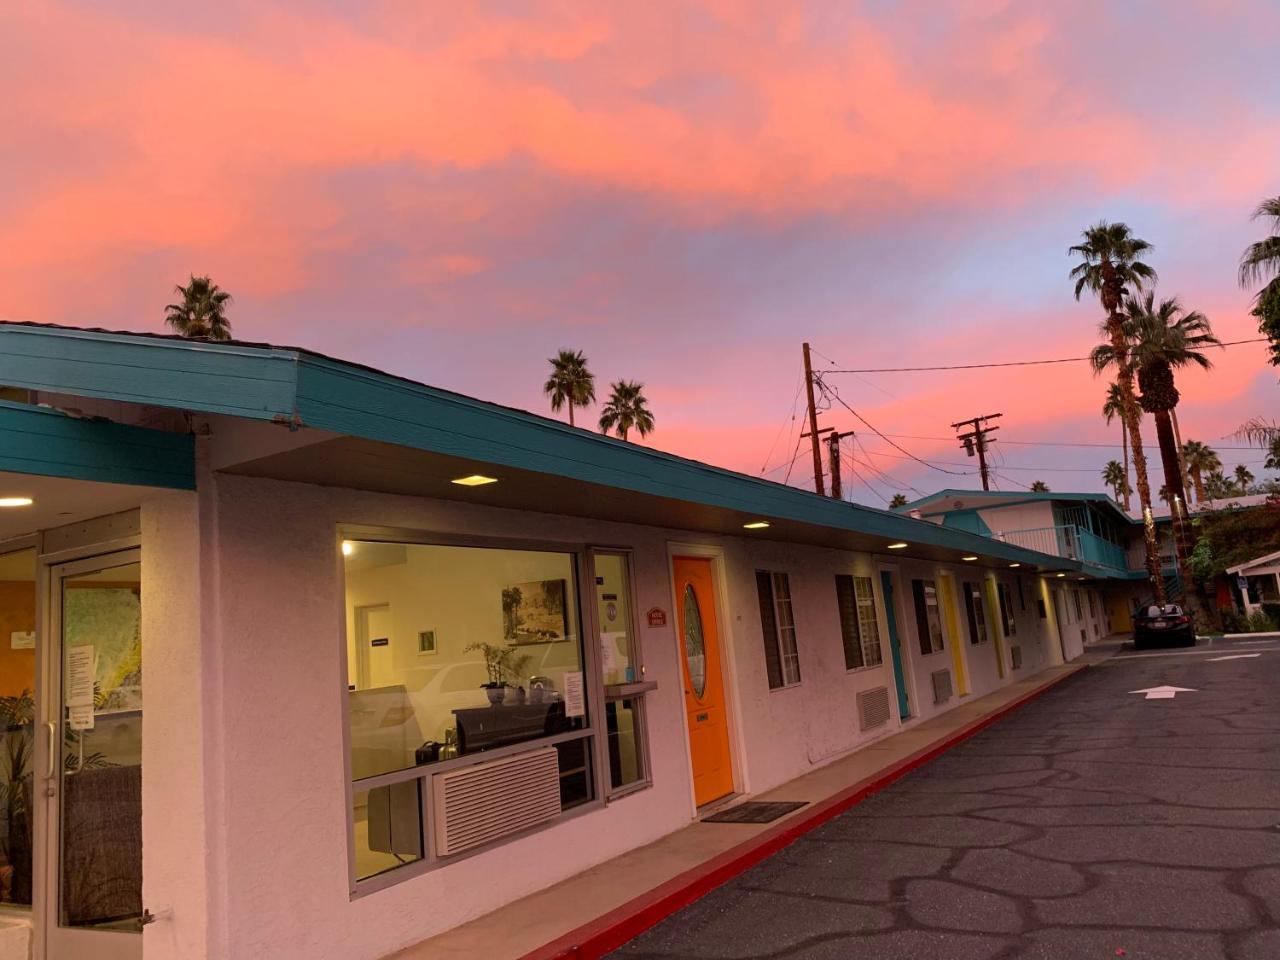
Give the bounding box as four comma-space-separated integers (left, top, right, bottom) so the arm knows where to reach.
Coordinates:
0, 323, 1100, 570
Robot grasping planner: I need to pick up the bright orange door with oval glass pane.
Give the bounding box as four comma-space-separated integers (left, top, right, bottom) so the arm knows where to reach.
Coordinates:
673, 557, 733, 806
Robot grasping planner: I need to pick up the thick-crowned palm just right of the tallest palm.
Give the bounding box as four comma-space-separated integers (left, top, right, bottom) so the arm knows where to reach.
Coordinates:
1091, 293, 1221, 624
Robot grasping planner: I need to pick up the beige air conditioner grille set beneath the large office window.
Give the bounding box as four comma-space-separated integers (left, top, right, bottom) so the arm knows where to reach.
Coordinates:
431, 746, 561, 856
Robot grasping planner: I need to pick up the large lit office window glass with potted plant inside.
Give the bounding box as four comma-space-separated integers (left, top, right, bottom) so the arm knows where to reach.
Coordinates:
343, 539, 595, 882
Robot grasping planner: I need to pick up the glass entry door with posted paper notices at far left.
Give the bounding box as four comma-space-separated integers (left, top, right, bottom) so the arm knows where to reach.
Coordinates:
44, 550, 143, 960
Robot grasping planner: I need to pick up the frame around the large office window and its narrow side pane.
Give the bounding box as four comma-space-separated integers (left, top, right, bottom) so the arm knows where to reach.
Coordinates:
333, 524, 632, 900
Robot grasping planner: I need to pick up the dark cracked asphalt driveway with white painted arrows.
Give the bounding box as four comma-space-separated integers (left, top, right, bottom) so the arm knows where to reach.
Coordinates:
612, 640, 1280, 960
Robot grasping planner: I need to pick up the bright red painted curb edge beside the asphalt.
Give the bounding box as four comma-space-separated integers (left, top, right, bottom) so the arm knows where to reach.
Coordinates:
520, 664, 1088, 960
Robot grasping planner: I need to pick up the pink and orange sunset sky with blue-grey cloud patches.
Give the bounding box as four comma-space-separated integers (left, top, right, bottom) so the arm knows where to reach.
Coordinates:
0, 0, 1280, 506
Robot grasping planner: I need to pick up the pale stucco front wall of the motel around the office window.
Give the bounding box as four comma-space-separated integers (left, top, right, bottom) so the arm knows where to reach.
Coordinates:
135, 474, 1080, 960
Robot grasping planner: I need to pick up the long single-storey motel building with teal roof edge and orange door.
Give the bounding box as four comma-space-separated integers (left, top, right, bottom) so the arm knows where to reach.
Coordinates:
0, 324, 1131, 960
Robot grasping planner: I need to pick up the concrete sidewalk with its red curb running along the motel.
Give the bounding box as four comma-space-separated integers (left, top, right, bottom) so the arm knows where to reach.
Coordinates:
396, 650, 1095, 960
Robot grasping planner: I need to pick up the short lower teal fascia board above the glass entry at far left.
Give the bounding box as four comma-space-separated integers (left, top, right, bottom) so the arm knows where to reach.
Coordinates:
0, 401, 196, 490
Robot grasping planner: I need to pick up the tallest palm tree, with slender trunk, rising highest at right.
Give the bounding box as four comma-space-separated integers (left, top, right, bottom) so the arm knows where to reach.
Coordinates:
1068, 220, 1165, 593
